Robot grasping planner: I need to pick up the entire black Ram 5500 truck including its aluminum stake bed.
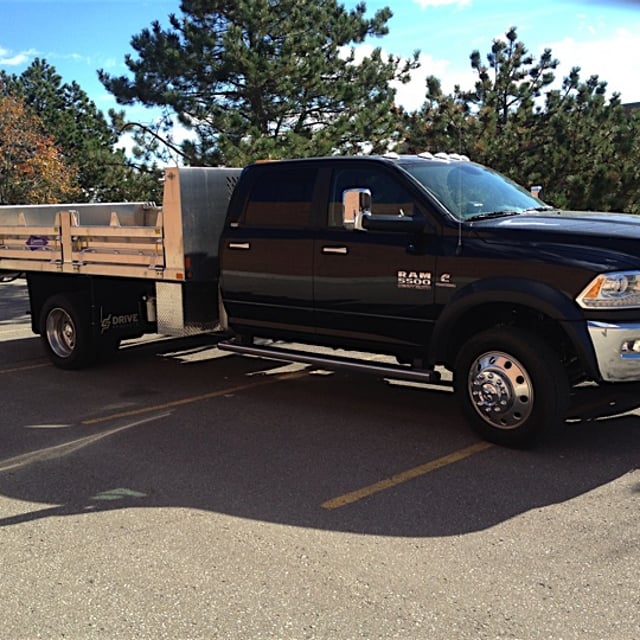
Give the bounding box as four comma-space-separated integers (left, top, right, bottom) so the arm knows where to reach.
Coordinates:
0, 154, 640, 445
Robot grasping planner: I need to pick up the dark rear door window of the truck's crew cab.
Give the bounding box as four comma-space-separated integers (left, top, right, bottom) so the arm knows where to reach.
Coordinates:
242, 165, 317, 228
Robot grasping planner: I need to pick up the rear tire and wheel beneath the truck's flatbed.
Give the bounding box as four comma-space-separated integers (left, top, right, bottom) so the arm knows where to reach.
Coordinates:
40, 294, 97, 369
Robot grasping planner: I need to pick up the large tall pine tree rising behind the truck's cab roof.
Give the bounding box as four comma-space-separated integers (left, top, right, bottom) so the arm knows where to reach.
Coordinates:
99, 0, 417, 165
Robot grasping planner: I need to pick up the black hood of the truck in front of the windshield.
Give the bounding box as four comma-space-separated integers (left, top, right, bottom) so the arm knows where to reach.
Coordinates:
470, 209, 640, 270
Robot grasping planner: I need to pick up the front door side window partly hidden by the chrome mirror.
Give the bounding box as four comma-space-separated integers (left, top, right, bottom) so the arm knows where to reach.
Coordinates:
328, 167, 414, 227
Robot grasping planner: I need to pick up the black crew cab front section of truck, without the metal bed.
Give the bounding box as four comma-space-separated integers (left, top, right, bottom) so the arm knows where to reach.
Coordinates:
219, 154, 640, 445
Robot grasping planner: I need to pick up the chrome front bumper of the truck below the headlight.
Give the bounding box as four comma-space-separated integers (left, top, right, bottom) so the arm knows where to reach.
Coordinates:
587, 321, 640, 382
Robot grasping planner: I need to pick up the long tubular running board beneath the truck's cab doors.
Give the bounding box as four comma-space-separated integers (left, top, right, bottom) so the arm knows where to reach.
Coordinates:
217, 340, 451, 386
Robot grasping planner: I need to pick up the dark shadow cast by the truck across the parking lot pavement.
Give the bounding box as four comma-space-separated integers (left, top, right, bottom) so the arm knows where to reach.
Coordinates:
0, 341, 640, 537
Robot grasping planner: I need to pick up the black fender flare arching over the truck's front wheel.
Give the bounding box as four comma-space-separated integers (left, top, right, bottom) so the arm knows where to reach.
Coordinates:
441, 302, 584, 379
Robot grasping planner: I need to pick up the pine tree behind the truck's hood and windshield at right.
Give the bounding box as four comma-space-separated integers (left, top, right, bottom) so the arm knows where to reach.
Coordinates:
401, 27, 640, 213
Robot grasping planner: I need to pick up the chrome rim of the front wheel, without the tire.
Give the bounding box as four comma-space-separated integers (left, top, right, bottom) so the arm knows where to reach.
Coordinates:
468, 351, 534, 429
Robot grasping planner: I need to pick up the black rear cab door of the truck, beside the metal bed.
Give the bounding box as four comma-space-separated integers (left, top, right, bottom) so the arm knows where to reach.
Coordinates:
220, 163, 317, 335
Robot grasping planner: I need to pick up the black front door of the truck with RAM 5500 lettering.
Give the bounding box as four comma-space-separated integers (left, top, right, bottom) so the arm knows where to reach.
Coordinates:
314, 161, 438, 348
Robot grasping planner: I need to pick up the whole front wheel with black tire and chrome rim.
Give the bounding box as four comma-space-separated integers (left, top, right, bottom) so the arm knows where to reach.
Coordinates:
454, 327, 569, 447
